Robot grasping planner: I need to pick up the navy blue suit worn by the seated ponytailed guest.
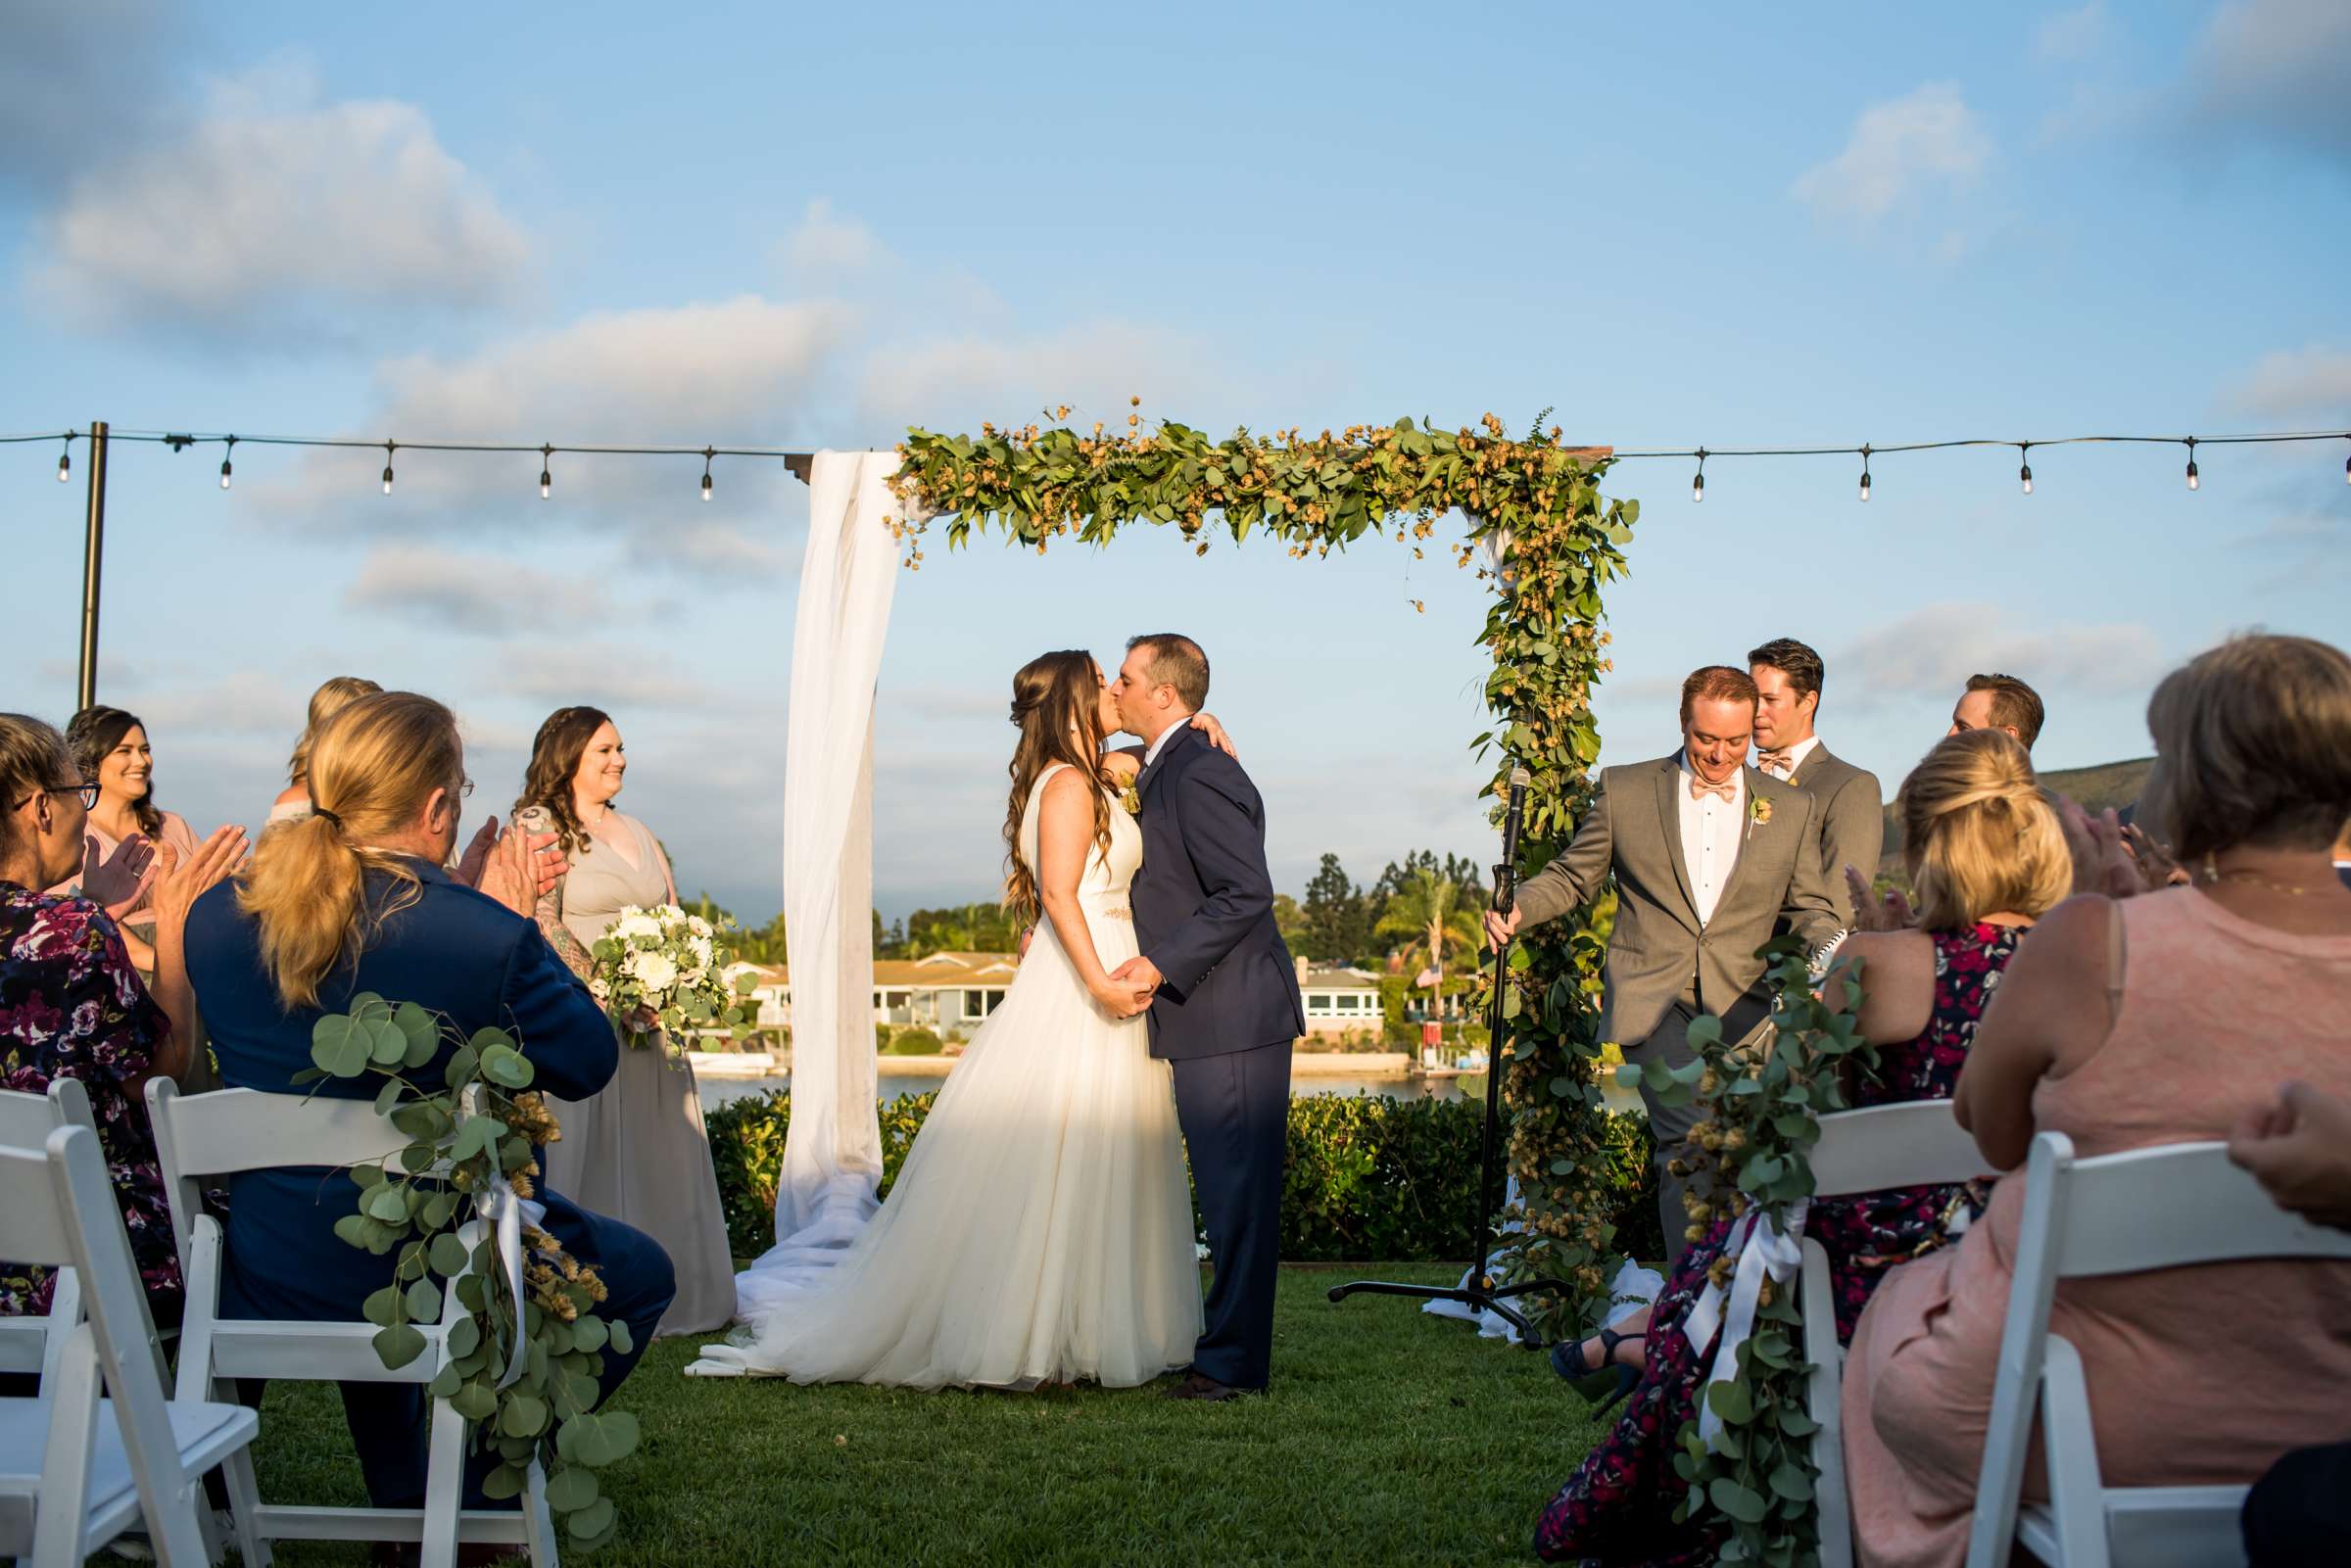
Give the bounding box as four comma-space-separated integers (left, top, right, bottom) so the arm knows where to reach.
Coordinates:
186, 861, 677, 1507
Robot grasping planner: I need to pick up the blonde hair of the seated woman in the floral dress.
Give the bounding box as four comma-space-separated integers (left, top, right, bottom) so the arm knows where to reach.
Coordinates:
1899, 729, 2074, 931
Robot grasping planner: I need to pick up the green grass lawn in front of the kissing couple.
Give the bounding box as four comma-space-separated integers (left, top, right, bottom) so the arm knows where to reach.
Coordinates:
243, 1264, 1599, 1568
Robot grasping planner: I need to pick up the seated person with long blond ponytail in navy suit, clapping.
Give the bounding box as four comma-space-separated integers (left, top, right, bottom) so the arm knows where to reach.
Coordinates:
188, 691, 672, 1507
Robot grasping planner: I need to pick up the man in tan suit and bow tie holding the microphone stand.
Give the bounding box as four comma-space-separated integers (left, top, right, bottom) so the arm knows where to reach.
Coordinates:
1486, 665, 1844, 1262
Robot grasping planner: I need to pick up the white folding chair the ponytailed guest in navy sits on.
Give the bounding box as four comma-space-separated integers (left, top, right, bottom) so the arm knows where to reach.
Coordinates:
146, 1079, 557, 1568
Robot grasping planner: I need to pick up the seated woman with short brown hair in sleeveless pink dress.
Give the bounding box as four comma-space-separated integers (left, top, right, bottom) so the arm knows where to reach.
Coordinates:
1846, 637, 2351, 1568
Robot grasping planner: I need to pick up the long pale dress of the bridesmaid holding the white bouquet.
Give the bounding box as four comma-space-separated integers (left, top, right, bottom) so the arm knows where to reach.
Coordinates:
541, 811, 734, 1335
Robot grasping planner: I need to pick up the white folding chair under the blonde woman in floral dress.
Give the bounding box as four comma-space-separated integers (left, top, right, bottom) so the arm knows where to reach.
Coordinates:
1799, 1100, 1989, 1568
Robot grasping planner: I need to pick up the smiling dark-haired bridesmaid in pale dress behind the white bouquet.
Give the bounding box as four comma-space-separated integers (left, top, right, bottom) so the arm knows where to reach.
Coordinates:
515, 707, 736, 1335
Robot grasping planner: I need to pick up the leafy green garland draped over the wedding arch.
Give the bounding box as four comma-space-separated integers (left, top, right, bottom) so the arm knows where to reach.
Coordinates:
893, 400, 1641, 1335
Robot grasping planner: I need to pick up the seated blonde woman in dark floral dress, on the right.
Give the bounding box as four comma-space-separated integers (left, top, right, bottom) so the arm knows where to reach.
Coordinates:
1535, 729, 2071, 1568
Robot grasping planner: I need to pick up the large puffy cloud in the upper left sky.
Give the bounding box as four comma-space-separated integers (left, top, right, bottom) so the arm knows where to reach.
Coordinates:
30, 66, 529, 334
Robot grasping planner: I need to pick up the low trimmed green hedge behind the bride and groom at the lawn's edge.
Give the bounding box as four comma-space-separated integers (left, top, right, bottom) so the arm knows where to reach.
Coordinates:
707, 1088, 1664, 1262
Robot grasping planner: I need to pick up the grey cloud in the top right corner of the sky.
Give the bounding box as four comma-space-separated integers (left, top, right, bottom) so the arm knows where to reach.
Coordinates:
2186, 0, 2351, 163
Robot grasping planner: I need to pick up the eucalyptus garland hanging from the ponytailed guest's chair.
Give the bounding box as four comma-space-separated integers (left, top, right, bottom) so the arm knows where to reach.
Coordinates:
301, 992, 637, 1549
